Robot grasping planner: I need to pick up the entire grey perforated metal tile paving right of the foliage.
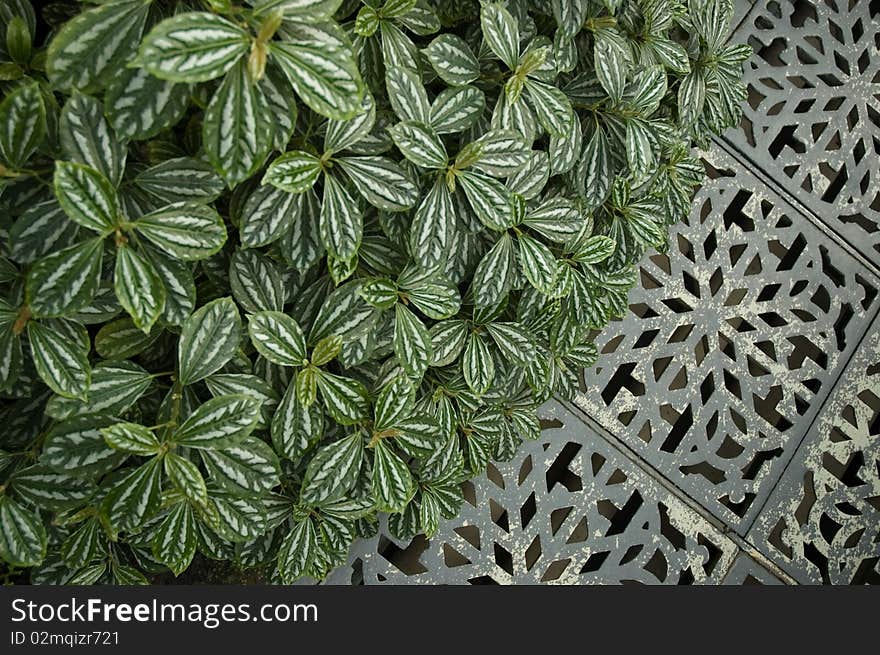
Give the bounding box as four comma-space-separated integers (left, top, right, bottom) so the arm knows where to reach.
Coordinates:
328, 0, 880, 584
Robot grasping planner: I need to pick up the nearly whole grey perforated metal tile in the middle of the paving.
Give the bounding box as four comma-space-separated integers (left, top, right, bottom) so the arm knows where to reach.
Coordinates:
577, 147, 880, 534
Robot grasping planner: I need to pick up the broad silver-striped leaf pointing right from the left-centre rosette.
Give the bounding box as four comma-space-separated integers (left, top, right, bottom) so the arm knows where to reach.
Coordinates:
134, 202, 226, 260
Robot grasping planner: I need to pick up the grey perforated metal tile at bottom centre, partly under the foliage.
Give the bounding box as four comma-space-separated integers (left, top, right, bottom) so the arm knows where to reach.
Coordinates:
330, 403, 736, 584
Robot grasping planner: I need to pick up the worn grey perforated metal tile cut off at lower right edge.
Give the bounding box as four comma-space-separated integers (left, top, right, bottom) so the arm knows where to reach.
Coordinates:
749, 323, 880, 584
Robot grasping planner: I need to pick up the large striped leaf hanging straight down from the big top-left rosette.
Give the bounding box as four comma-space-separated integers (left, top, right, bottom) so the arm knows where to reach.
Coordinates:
202, 62, 272, 188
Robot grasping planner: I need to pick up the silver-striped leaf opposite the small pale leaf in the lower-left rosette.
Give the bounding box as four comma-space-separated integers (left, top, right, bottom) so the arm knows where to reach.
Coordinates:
172, 394, 260, 448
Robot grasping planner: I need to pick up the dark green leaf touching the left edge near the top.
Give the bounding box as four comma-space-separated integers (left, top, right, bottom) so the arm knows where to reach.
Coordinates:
0, 82, 46, 168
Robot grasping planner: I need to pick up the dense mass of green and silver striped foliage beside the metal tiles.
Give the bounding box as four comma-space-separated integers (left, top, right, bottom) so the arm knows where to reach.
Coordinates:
0, 0, 748, 583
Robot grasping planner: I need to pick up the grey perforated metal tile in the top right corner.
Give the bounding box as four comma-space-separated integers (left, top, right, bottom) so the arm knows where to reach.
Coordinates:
726, 0, 880, 268
